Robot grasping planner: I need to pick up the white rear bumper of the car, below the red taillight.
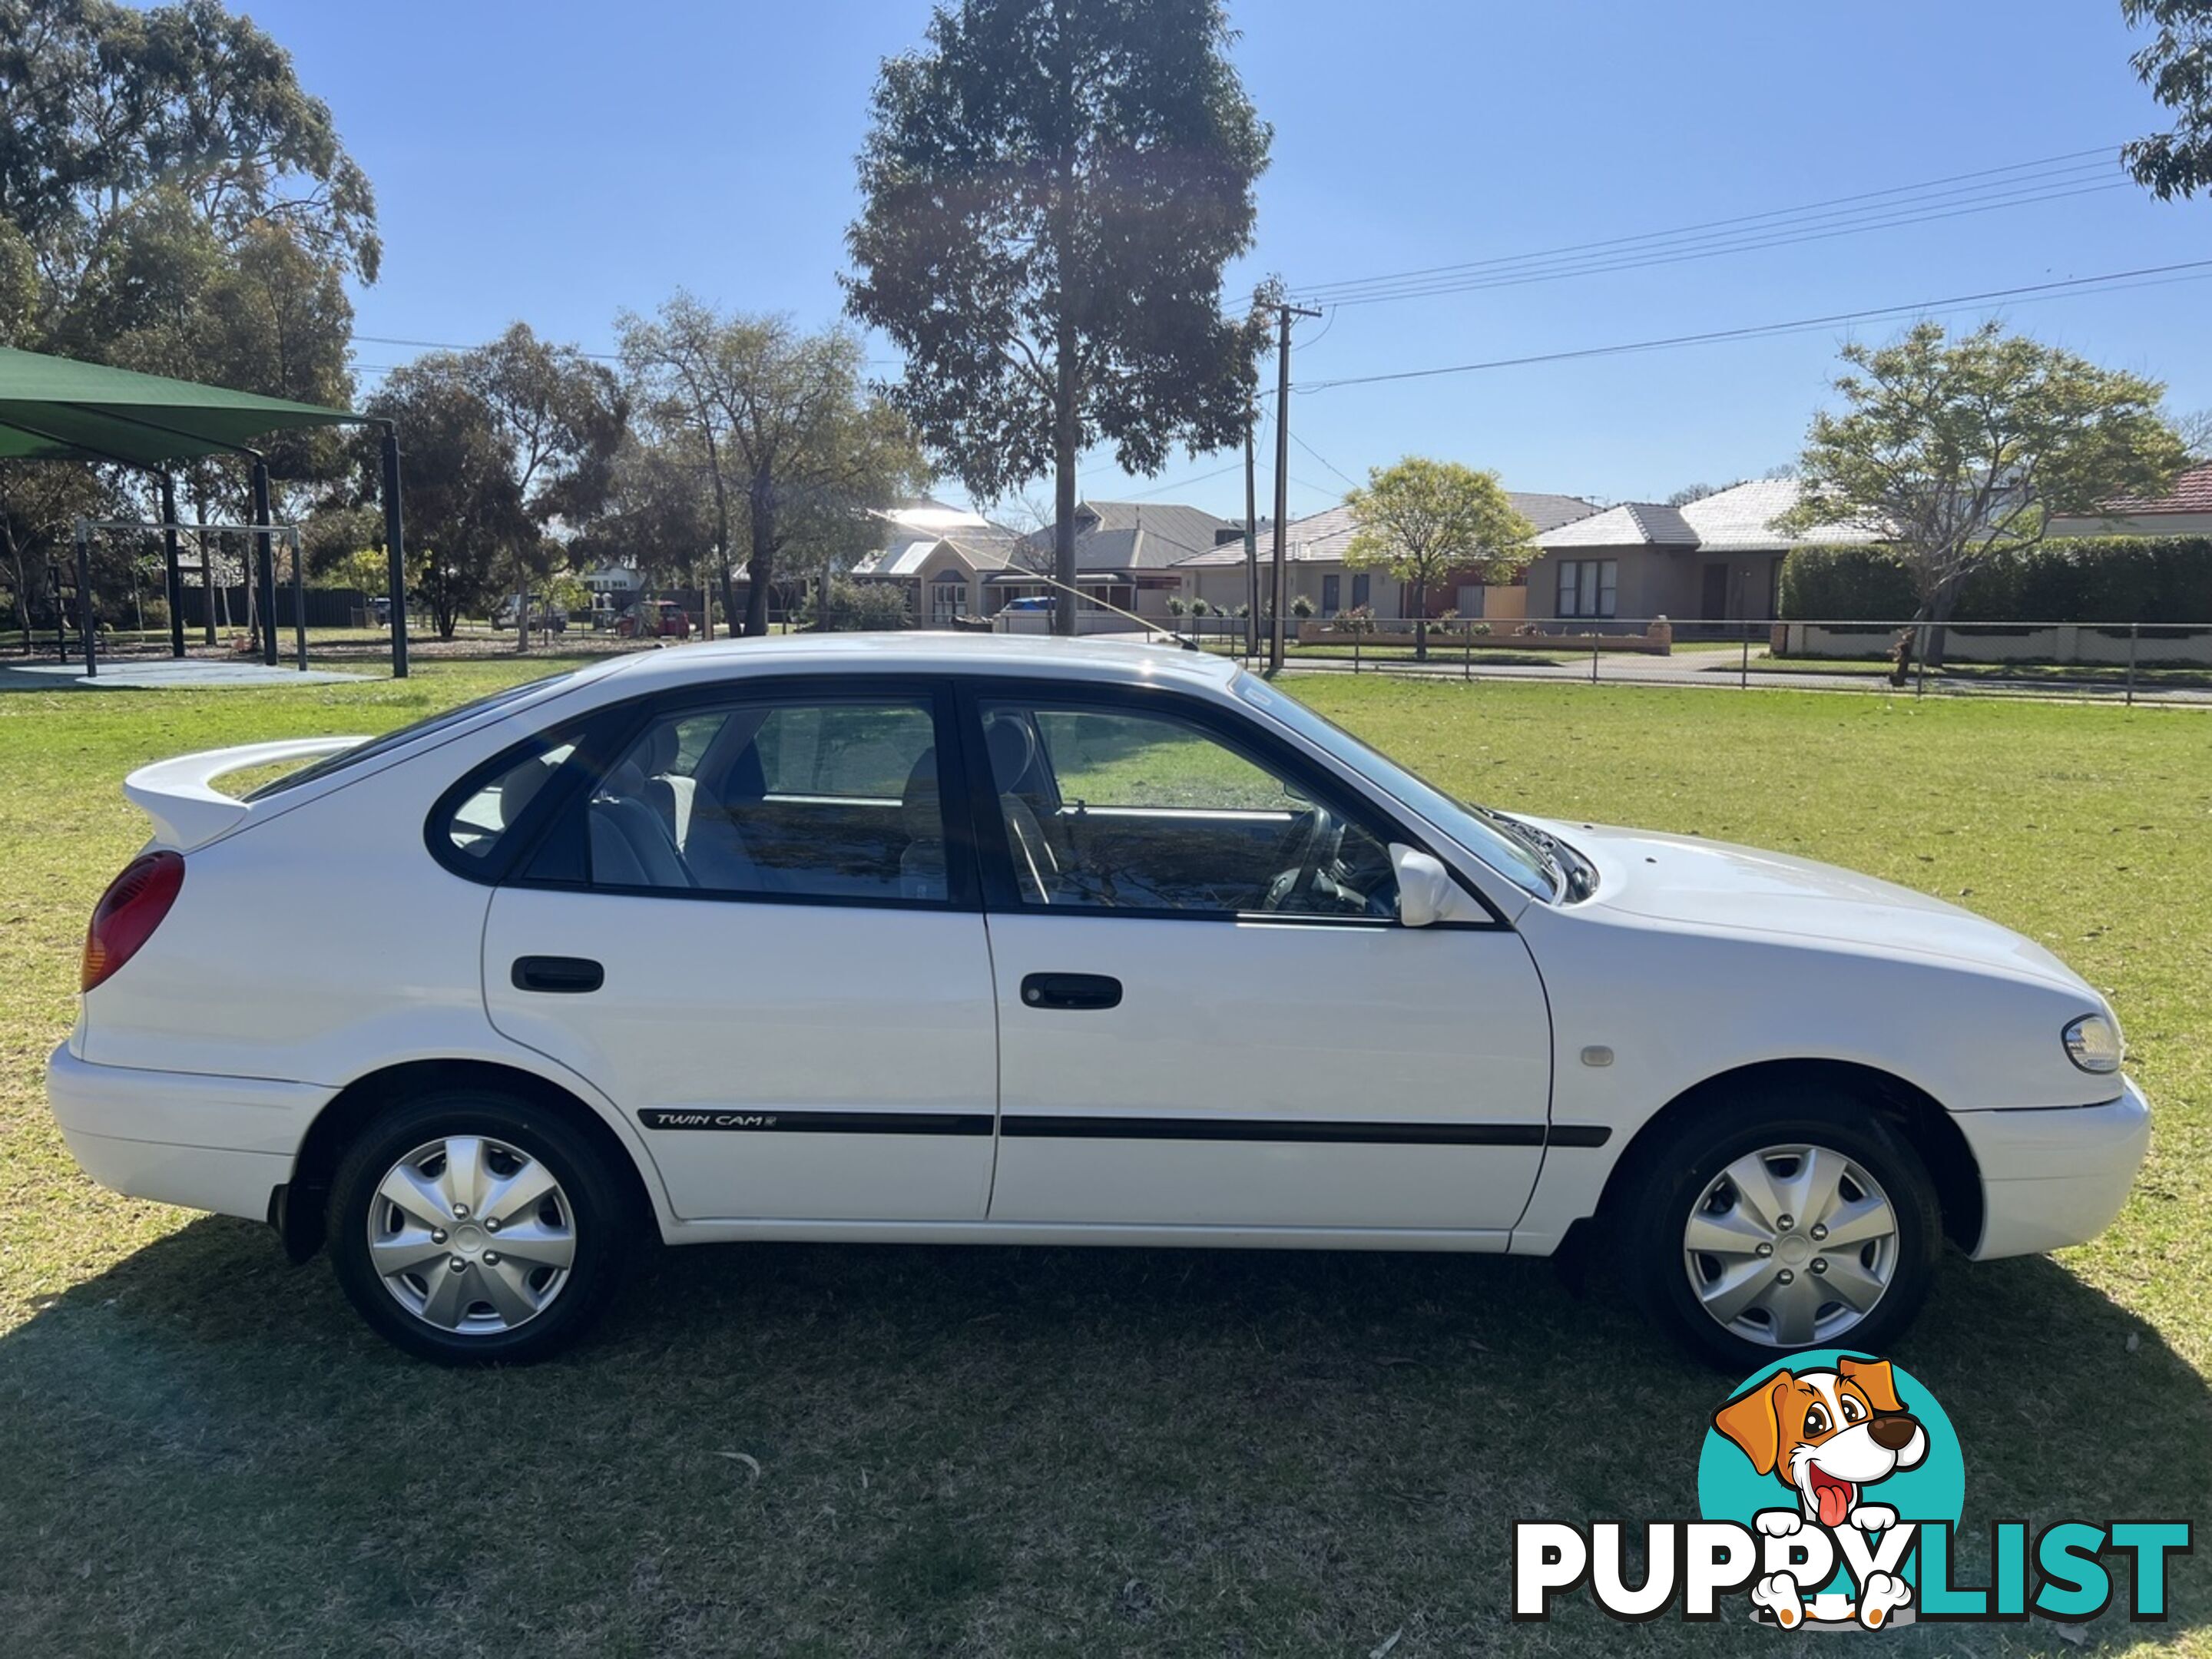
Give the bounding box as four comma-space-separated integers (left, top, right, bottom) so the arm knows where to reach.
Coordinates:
46, 1044, 336, 1221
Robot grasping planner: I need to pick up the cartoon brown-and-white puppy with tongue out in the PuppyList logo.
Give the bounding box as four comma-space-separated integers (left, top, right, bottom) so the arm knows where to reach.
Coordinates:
1712, 1356, 1929, 1631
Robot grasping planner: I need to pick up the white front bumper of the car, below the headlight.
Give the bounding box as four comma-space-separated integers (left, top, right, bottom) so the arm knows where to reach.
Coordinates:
1951, 1078, 2150, 1261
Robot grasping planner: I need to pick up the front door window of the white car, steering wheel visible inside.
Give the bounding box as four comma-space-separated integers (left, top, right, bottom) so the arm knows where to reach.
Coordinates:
982, 701, 1398, 920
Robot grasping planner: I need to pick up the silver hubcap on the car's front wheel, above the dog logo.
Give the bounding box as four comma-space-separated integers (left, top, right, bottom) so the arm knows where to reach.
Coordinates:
1681, 1146, 1898, 1347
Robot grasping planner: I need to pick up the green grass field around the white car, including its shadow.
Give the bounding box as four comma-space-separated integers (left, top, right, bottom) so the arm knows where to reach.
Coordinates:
0, 657, 2212, 1659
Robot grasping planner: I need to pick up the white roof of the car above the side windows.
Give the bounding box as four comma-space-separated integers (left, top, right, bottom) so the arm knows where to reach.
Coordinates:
601, 633, 1237, 694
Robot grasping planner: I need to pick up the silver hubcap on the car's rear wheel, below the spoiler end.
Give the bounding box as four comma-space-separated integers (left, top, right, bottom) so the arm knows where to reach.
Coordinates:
369, 1134, 575, 1336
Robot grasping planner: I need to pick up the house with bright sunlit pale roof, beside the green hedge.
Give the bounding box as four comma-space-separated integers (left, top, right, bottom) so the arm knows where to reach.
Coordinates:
1526, 478, 1883, 633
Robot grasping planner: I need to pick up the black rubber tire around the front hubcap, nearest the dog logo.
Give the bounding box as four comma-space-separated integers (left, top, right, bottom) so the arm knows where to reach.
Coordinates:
1621, 1088, 1942, 1376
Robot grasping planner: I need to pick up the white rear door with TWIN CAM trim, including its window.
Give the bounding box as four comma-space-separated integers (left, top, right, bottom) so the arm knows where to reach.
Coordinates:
484, 688, 995, 1221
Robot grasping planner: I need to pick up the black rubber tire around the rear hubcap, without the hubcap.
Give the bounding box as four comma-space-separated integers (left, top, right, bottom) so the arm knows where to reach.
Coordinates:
329, 1088, 646, 1365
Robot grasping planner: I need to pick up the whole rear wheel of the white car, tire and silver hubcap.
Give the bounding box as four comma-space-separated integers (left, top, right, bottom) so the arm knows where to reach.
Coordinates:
329, 1091, 639, 1365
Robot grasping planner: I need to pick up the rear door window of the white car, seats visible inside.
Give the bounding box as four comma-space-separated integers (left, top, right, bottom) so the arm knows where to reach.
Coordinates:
581, 699, 947, 902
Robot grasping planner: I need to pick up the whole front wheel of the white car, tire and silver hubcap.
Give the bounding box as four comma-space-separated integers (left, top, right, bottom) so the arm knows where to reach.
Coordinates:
1624, 1091, 1942, 1373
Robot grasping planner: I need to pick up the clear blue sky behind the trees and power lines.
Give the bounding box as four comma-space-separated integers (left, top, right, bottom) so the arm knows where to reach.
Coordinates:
252, 0, 2212, 513
